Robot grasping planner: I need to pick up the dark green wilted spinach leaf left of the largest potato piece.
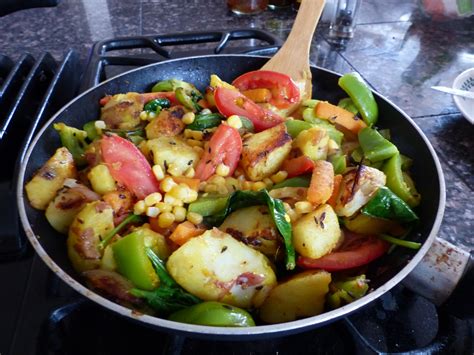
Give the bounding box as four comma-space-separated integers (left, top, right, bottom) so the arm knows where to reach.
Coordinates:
130, 248, 202, 315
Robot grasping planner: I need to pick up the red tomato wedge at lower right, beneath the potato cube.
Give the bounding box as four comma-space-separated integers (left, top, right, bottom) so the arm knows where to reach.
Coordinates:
297, 231, 390, 271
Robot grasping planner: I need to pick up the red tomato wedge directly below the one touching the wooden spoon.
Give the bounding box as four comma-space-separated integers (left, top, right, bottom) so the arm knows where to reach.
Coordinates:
214, 87, 284, 132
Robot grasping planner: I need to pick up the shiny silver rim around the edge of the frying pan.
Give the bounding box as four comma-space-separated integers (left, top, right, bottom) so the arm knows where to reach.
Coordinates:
16, 54, 446, 340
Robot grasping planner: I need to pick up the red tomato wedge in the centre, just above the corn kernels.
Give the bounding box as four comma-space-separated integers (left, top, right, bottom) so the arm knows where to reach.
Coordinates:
194, 124, 242, 181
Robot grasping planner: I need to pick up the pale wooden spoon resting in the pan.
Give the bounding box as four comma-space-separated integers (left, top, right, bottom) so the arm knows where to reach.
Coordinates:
262, 0, 325, 100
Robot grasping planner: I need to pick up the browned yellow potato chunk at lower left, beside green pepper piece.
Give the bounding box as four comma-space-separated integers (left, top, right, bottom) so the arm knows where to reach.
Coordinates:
67, 201, 114, 272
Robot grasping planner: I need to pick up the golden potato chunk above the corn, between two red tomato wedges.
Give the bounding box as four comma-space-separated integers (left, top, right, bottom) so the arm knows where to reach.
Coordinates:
147, 136, 199, 175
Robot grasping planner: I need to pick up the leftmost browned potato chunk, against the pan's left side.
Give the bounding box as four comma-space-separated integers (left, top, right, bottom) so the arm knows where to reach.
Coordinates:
25, 147, 76, 210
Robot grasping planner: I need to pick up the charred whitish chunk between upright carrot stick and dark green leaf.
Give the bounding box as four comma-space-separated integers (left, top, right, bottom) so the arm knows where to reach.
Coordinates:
334, 165, 386, 217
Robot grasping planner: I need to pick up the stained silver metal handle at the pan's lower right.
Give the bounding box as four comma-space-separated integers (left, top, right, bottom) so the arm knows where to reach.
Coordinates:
403, 237, 474, 312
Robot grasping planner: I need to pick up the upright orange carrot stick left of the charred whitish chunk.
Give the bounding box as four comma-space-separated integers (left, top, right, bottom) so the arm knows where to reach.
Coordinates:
307, 160, 334, 205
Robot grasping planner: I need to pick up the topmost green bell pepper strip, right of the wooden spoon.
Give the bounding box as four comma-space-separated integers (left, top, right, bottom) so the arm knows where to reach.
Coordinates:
338, 72, 379, 126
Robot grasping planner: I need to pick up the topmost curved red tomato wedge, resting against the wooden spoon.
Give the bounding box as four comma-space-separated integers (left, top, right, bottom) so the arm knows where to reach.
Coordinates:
232, 70, 300, 108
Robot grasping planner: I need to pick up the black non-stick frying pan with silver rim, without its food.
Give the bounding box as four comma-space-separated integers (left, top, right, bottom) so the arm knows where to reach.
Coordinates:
17, 55, 445, 340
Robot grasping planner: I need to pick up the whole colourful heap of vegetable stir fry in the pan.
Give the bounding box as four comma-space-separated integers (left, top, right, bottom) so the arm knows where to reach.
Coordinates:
25, 71, 420, 327
